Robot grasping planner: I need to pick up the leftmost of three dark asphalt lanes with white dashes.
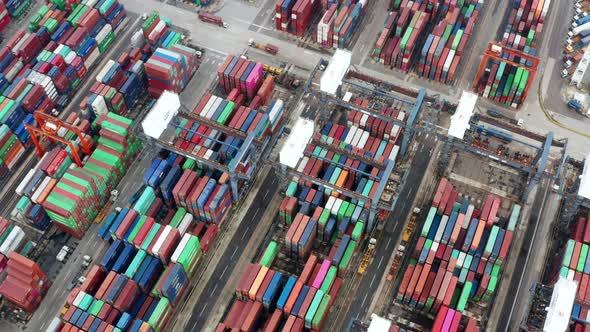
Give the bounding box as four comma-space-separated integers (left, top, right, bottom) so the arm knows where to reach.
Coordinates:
185, 172, 279, 332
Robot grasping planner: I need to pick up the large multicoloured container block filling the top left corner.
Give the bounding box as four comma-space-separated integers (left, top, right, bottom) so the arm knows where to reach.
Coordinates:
0, 0, 126, 179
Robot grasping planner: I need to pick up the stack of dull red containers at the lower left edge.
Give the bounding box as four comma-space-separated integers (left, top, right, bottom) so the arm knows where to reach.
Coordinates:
0, 252, 49, 313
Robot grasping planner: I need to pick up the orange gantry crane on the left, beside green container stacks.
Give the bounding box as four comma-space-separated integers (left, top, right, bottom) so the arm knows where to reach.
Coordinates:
25, 111, 92, 167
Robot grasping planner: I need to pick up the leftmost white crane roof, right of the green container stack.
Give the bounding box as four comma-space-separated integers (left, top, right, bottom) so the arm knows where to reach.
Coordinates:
141, 91, 180, 139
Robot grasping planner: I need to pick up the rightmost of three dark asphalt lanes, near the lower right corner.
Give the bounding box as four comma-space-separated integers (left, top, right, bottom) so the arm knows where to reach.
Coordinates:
496, 180, 551, 331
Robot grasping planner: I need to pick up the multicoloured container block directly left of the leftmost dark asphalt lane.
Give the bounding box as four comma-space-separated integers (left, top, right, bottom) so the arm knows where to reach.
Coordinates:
60, 151, 227, 331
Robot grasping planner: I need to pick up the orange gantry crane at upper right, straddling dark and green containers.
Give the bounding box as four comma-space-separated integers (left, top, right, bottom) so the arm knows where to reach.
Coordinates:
473, 42, 539, 105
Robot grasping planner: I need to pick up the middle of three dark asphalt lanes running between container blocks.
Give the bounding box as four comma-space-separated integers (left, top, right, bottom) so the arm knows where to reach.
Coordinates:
340, 136, 436, 330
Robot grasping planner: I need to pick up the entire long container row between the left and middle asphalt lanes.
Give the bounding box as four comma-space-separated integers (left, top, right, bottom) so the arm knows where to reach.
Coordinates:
217, 91, 412, 331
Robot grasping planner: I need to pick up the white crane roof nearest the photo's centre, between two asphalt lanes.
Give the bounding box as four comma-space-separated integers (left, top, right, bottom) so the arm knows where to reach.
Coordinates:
279, 118, 314, 168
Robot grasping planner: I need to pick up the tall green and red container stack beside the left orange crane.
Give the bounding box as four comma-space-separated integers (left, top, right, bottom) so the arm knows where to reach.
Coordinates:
42, 113, 141, 238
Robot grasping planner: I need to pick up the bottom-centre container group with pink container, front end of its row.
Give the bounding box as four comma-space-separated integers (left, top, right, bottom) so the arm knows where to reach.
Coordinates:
216, 252, 343, 331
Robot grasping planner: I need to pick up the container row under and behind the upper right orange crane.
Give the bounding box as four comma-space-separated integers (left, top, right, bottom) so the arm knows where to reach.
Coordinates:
475, 0, 551, 108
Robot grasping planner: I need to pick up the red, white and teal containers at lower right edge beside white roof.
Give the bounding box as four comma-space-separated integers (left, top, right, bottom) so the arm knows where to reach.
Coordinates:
559, 217, 590, 331
